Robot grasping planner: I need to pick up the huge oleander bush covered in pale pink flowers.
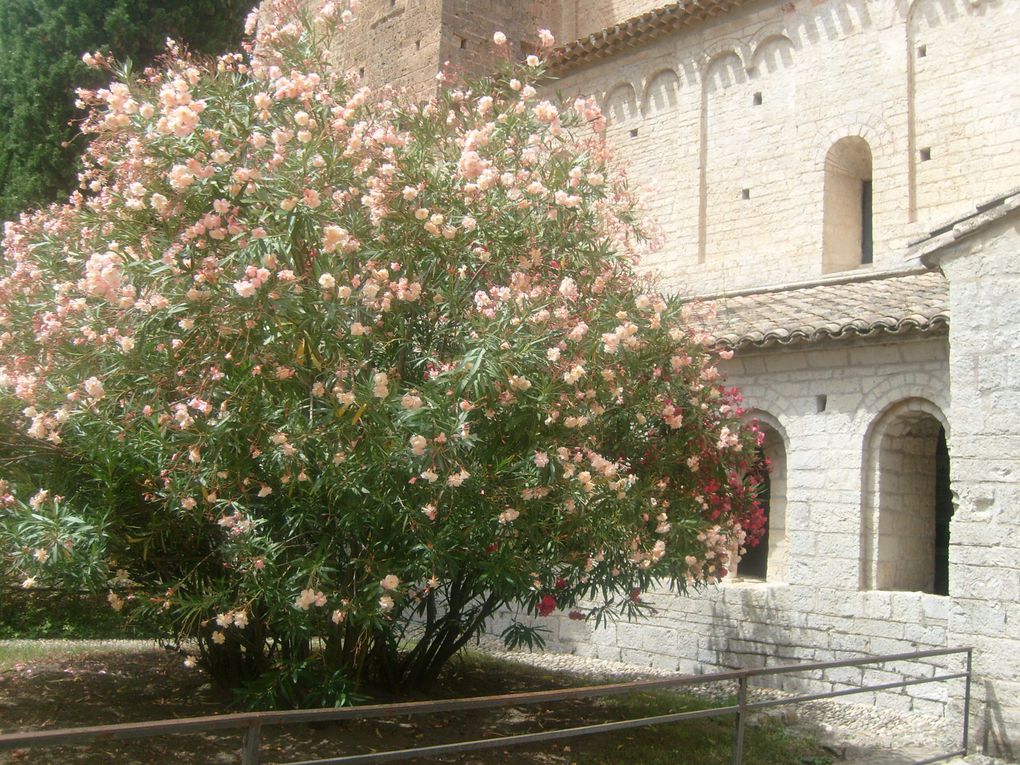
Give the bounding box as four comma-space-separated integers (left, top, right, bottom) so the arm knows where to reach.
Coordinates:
0, 0, 762, 704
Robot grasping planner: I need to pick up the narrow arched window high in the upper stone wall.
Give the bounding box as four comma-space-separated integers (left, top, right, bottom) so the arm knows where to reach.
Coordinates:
822, 136, 874, 273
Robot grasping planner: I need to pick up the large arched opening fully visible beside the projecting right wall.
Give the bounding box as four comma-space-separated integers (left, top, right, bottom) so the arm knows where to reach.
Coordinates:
866, 401, 953, 595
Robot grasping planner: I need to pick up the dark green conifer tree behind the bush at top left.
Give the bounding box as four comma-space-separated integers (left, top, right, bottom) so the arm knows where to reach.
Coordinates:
0, 0, 254, 221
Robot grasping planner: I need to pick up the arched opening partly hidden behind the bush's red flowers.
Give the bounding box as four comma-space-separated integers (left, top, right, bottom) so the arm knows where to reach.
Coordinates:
736, 421, 786, 581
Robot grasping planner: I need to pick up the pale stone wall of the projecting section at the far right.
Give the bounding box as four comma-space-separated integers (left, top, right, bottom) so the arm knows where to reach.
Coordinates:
926, 211, 1020, 757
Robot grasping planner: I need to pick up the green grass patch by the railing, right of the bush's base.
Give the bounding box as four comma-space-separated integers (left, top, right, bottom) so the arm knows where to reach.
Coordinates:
572, 691, 832, 765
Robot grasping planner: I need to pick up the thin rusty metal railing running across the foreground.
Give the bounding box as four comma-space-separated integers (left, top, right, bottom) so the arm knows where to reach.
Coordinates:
0, 648, 973, 765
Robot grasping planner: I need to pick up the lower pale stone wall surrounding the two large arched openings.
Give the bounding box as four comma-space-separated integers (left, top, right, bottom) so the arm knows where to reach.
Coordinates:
491, 337, 965, 715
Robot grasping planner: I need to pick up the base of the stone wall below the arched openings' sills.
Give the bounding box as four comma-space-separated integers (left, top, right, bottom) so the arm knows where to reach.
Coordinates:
490, 582, 963, 717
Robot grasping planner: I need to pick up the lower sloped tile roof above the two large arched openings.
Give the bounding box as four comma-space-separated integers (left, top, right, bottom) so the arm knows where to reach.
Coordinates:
692, 271, 950, 348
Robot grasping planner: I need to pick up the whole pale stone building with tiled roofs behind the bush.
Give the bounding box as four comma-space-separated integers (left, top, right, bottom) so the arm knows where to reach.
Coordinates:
322, 0, 1020, 754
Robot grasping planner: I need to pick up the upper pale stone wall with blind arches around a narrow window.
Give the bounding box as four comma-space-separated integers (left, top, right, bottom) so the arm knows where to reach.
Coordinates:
556, 0, 1020, 293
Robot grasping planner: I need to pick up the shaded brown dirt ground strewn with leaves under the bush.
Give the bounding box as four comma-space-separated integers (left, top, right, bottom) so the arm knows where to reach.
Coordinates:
0, 650, 767, 765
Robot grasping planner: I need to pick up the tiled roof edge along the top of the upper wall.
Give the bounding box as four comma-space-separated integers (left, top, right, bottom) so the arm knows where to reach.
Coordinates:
551, 0, 746, 72
